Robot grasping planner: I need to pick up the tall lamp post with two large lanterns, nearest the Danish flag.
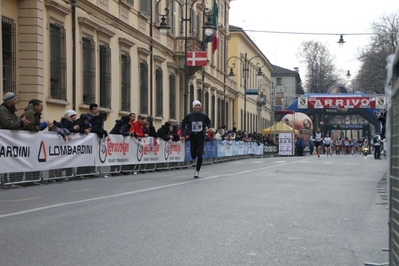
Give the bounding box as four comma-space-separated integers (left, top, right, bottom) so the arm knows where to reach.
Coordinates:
156, 0, 217, 115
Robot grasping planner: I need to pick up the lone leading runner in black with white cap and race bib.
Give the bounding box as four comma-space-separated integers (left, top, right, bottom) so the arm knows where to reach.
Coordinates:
180, 101, 211, 178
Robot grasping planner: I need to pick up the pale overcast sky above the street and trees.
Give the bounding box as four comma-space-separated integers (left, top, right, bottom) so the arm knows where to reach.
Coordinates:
230, 0, 399, 81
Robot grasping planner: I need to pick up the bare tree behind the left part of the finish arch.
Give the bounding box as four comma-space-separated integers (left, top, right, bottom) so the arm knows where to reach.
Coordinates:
297, 40, 338, 92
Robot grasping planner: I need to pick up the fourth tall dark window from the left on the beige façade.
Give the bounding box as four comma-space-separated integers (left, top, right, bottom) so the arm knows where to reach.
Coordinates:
100, 45, 111, 109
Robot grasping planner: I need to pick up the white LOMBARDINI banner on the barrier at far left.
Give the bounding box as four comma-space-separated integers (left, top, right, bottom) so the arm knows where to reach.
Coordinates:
0, 130, 97, 173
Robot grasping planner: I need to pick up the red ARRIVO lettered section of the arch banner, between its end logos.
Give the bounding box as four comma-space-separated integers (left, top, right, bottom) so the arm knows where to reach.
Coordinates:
307, 96, 376, 109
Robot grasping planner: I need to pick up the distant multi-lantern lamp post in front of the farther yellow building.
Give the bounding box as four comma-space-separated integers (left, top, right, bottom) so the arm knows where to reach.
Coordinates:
227, 53, 266, 131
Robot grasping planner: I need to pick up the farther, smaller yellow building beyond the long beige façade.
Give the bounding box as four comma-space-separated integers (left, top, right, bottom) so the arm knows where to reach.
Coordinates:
227, 26, 273, 133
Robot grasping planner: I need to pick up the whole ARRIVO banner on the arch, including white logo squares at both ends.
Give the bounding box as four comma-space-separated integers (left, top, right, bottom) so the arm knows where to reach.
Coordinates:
298, 95, 385, 109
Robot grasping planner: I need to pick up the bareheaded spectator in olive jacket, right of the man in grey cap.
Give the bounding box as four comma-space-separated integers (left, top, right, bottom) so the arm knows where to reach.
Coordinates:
20, 99, 52, 132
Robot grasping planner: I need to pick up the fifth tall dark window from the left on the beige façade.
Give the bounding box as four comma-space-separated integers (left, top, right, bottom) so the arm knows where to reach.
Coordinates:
121, 54, 131, 112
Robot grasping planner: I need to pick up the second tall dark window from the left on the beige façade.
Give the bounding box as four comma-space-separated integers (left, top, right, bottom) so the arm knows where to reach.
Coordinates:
50, 24, 67, 101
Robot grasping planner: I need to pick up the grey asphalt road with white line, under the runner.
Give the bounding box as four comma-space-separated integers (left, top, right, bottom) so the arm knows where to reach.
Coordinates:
0, 156, 389, 266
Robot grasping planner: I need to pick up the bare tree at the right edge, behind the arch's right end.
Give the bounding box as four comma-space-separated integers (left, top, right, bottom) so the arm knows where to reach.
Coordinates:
355, 12, 399, 94
